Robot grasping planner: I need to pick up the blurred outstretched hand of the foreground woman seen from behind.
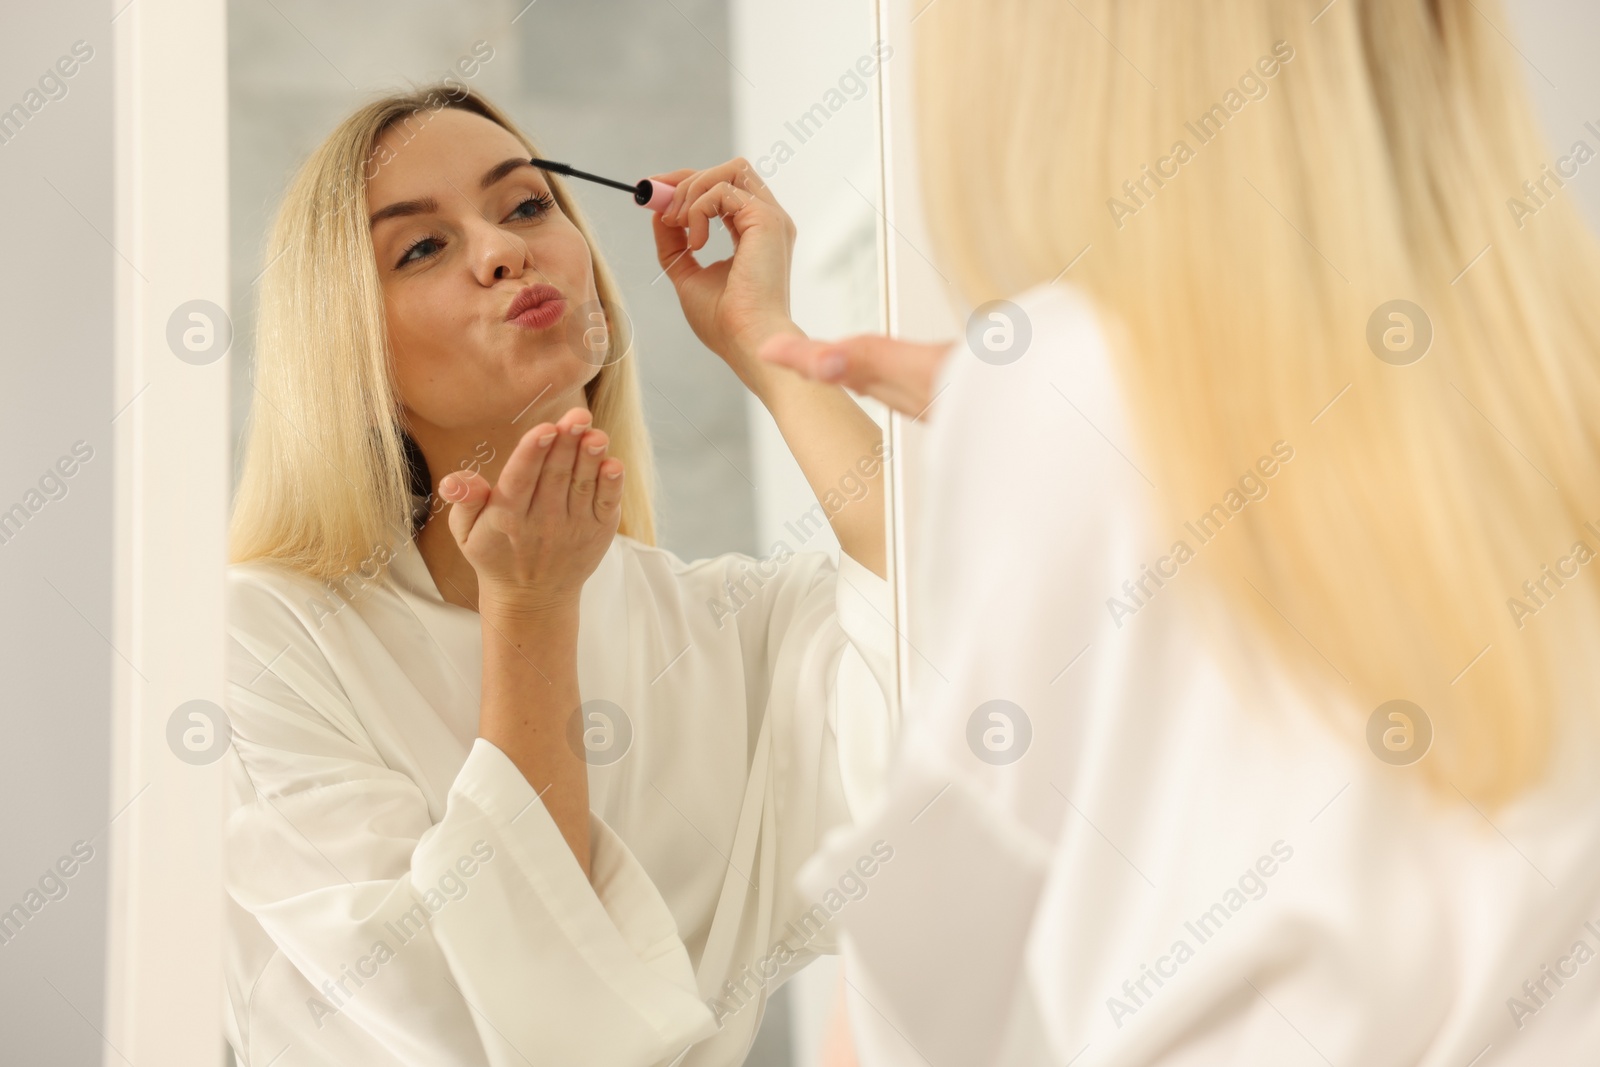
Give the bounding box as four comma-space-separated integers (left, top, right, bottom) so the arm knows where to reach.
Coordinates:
760, 333, 952, 419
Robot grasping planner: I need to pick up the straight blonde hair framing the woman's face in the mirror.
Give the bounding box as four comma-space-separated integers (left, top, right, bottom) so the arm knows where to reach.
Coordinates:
229, 86, 654, 581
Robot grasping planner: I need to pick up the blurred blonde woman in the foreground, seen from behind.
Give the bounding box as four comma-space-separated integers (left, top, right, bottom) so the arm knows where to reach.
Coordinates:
763, 0, 1600, 1067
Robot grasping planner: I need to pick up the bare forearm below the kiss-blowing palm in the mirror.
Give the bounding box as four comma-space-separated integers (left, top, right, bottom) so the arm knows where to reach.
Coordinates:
478, 605, 590, 877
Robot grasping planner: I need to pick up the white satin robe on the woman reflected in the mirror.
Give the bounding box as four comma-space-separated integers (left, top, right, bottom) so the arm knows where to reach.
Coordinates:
224, 536, 893, 1067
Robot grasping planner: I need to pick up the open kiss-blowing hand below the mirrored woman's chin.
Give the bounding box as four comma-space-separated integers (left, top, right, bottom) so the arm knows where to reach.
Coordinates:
438, 408, 622, 617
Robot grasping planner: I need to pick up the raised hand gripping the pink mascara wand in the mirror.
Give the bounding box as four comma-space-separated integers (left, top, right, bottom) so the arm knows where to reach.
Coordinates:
651, 158, 800, 389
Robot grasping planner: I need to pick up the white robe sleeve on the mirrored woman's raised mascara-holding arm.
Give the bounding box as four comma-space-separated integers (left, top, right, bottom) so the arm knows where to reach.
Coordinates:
713, 552, 899, 974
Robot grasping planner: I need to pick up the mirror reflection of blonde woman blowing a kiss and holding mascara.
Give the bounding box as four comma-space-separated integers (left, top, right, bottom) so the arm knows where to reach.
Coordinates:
226, 83, 891, 1065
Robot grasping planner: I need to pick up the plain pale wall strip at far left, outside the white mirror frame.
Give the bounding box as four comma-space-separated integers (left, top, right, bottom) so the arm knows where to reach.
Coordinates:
0, 0, 114, 1064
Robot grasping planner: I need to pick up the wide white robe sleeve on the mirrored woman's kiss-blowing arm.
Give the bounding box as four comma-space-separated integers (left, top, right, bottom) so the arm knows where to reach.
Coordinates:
224, 581, 714, 1067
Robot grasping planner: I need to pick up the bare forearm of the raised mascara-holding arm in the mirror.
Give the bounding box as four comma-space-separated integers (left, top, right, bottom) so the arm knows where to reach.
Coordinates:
752, 358, 888, 577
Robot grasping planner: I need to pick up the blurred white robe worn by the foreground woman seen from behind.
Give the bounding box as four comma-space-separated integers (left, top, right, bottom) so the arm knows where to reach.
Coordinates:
800, 288, 1600, 1067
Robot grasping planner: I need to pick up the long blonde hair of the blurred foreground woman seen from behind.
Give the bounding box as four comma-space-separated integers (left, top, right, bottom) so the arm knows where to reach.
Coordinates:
917, 0, 1600, 803
